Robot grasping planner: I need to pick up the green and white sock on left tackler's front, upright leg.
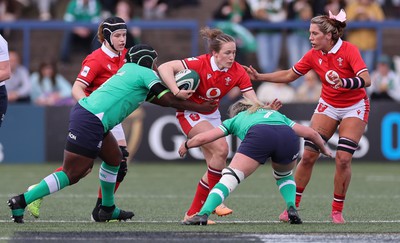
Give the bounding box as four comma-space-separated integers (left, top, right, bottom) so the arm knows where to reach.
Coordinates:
99, 162, 119, 207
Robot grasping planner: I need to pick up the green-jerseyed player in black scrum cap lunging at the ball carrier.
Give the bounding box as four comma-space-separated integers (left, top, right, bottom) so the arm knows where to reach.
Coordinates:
8, 45, 215, 223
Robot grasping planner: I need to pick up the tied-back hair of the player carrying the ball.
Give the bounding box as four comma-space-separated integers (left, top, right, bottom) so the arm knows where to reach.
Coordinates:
200, 27, 235, 52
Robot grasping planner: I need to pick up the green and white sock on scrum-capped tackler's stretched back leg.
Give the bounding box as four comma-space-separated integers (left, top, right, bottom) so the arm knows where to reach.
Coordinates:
24, 171, 69, 204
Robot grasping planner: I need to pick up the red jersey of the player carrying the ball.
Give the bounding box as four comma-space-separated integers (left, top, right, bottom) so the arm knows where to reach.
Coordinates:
182, 54, 253, 113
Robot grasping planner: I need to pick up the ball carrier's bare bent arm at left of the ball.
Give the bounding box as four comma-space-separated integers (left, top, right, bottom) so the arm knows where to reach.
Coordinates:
158, 60, 185, 96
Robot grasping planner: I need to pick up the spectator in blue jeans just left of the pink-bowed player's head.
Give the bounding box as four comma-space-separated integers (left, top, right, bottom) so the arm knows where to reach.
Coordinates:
286, 0, 313, 88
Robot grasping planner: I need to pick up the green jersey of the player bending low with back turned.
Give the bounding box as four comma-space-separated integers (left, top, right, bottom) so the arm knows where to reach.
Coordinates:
219, 109, 296, 140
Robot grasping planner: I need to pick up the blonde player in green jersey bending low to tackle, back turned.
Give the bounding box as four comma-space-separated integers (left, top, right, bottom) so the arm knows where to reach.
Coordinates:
179, 99, 332, 225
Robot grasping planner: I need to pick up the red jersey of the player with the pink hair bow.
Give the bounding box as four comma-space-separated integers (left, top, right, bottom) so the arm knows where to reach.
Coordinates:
292, 39, 367, 108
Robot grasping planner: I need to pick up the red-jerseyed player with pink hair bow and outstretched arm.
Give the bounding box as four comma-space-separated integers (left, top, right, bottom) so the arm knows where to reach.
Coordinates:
245, 10, 371, 224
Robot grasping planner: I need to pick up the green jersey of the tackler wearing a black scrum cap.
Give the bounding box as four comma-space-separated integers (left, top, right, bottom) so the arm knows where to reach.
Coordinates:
79, 63, 161, 132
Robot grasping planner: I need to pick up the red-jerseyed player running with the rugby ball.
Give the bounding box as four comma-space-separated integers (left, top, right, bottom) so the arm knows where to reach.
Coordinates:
158, 28, 281, 224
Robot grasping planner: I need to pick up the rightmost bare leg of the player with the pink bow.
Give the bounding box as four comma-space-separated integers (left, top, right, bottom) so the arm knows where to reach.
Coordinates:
331, 117, 366, 224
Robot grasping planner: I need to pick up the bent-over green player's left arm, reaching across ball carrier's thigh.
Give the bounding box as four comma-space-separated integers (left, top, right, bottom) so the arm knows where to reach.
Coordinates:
178, 127, 225, 157
